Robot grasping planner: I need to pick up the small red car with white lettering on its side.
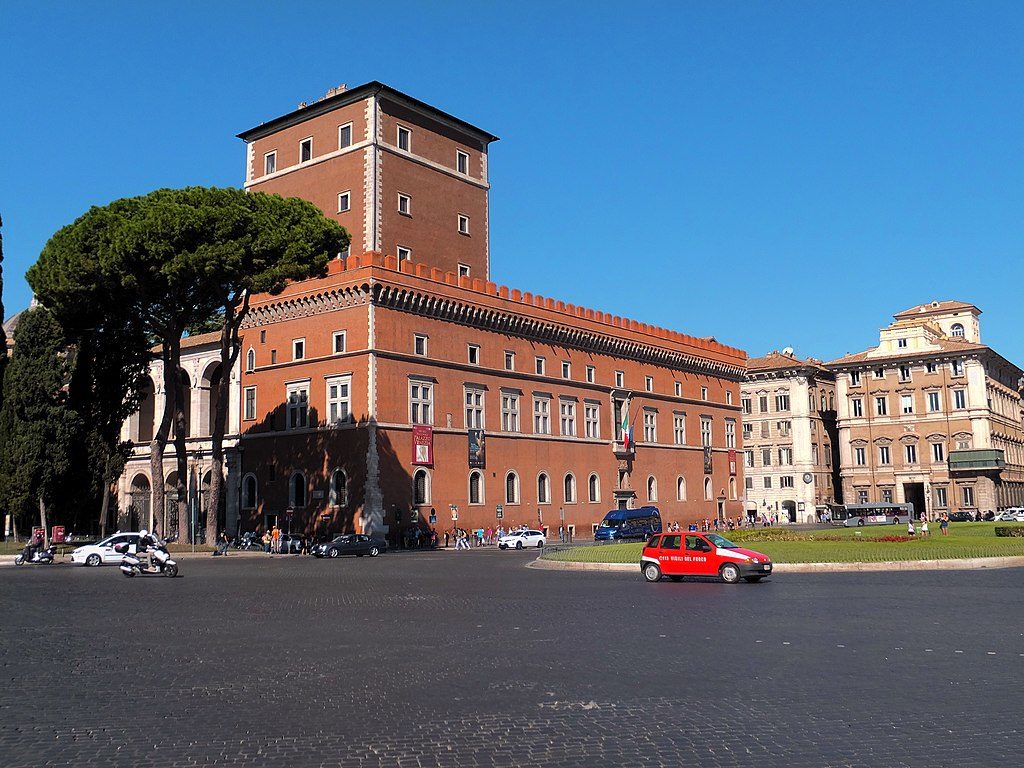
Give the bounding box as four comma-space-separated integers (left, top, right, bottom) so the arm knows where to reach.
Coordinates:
640, 532, 771, 584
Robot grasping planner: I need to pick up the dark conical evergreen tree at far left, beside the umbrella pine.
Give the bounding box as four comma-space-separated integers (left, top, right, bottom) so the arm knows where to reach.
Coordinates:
0, 307, 80, 540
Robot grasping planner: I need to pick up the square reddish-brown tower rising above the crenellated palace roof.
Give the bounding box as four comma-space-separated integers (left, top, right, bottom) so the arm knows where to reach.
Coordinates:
239, 81, 498, 280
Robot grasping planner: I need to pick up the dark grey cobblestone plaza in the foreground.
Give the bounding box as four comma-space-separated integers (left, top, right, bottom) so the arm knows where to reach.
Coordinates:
0, 551, 1024, 768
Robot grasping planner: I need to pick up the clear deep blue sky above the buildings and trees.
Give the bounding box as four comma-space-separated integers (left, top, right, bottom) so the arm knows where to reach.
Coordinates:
0, 0, 1024, 365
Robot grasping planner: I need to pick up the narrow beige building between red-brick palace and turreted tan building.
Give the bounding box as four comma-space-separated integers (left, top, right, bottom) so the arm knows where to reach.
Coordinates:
740, 349, 842, 523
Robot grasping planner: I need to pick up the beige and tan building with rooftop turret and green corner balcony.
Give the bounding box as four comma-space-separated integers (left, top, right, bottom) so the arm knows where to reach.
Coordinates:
828, 301, 1024, 517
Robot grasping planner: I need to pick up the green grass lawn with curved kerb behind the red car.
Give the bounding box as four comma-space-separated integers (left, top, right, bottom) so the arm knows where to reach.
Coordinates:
544, 522, 1024, 563
